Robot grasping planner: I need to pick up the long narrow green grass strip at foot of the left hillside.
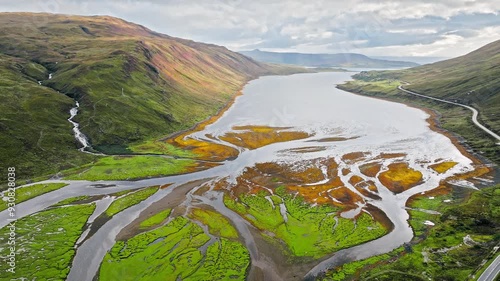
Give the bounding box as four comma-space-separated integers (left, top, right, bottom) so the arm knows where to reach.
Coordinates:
64, 156, 196, 181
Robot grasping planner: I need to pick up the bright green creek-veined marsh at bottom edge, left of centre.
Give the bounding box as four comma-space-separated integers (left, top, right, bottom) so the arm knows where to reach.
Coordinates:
99, 217, 250, 281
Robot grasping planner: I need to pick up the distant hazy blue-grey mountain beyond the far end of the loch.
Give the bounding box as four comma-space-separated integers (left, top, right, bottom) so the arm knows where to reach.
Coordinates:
240, 50, 418, 68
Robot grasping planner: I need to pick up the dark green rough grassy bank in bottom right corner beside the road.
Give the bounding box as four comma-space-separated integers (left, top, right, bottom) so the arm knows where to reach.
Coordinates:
318, 185, 500, 280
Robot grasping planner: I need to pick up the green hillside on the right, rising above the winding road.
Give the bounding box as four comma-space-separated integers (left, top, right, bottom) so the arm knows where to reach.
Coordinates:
355, 40, 500, 132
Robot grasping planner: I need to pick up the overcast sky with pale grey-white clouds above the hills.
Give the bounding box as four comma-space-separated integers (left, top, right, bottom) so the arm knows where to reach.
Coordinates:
0, 0, 500, 57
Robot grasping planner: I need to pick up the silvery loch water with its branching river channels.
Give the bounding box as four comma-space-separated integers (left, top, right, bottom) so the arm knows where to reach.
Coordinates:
0, 72, 473, 281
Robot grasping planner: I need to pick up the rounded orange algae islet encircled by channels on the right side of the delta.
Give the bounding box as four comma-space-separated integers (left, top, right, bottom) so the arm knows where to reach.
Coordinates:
378, 163, 422, 193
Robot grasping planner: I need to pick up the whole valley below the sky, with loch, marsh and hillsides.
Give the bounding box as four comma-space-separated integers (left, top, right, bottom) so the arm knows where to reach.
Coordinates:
0, 12, 500, 281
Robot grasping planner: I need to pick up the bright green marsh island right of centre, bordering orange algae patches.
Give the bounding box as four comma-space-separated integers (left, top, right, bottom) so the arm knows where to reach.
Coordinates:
224, 187, 386, 259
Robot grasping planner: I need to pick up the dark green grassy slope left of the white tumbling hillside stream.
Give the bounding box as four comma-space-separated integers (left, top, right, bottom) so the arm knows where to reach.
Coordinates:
0, 54, 93, 177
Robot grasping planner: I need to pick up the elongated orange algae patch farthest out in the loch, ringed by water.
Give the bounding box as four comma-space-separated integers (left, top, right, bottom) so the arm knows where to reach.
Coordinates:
220, 126, 311, 149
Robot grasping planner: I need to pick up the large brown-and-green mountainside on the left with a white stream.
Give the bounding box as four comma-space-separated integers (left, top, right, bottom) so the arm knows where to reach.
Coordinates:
0, 13, 304, 176
